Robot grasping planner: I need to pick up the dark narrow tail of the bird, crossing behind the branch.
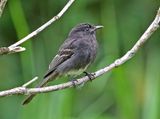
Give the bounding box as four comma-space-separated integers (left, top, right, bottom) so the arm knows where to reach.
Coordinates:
22, 72, 58, 105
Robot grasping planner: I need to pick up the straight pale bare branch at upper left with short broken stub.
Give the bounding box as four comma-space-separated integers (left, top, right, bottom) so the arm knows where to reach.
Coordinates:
0, 0, 75, 55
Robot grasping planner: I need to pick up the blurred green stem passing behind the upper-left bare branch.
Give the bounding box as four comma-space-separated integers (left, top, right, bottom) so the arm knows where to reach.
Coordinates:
9, 0, 34, 81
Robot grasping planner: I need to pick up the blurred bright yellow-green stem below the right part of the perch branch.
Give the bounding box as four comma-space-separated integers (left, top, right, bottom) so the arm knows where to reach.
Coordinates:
114, 67, 137, 119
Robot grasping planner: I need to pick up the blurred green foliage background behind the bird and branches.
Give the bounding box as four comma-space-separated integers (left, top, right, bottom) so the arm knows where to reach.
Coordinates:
0, 0, 160, 119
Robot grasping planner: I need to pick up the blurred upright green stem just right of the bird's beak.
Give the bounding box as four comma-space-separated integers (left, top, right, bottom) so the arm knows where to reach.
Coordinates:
101, 0, 119, 61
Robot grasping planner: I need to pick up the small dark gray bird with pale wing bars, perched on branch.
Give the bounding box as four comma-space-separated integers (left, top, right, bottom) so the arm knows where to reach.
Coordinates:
23, 23, 103, 105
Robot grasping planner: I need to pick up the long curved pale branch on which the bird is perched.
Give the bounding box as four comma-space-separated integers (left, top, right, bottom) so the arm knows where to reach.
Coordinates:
0, 8, 160, 97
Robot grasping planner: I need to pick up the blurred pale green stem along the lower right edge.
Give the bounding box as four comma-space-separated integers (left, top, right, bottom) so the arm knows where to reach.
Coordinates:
142, 48, 160, 119
